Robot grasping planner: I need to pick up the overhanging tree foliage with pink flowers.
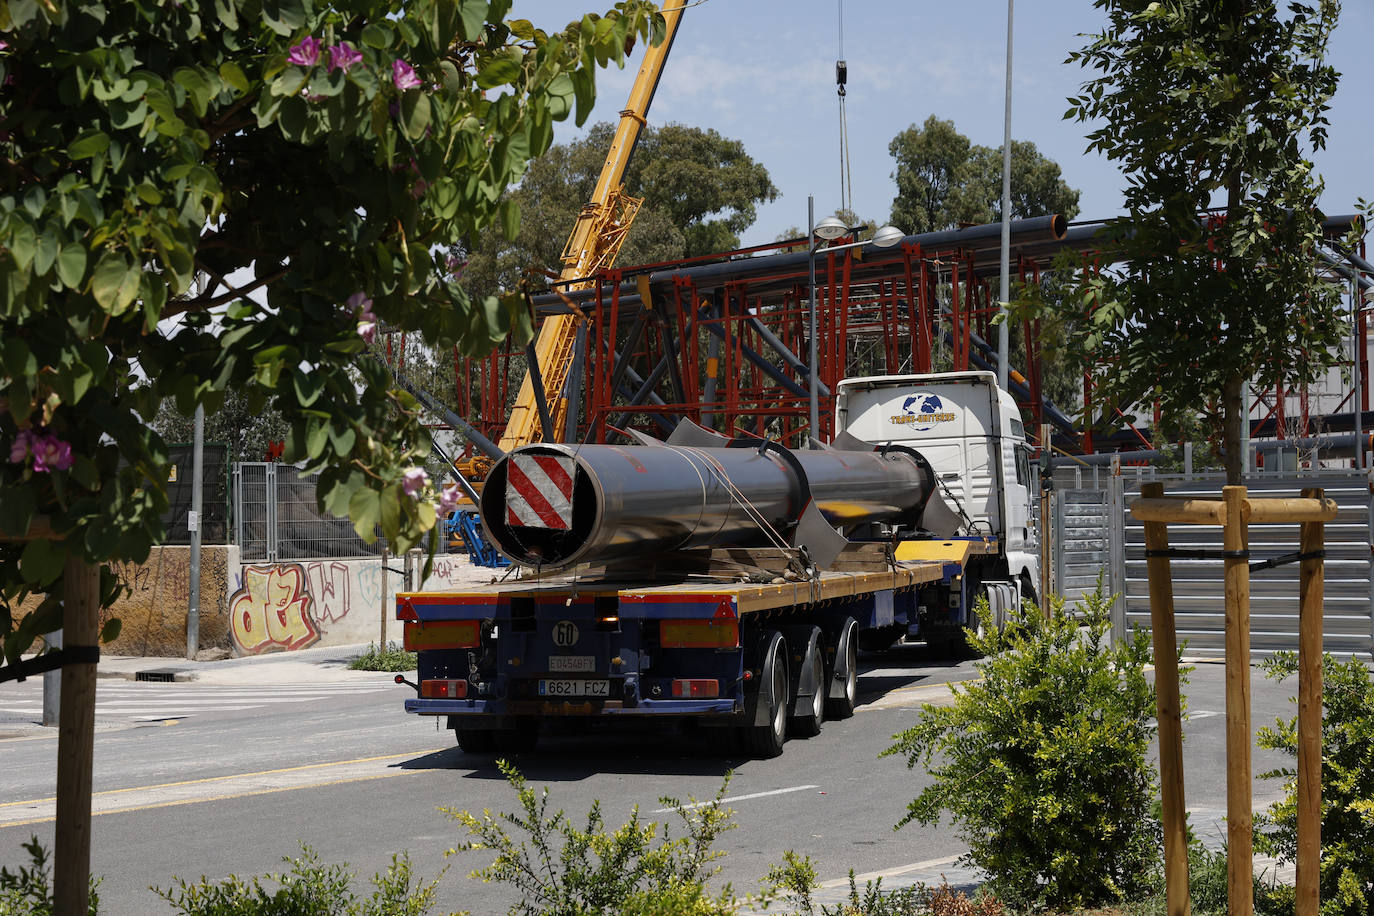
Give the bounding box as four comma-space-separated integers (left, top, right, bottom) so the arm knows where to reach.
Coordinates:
0, 0, 662, 659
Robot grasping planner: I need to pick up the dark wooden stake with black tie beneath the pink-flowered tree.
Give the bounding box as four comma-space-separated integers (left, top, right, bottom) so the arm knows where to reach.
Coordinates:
52, 549, 100, 916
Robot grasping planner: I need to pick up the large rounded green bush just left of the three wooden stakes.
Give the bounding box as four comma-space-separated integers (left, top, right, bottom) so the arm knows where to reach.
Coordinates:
883, 588, 1161, 909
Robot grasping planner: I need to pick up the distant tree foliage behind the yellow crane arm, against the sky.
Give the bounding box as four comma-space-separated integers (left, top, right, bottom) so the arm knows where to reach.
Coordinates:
463, 122, 778, 294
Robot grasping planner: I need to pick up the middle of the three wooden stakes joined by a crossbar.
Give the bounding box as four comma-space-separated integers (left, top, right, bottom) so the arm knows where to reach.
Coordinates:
1221, 486, 1254, 916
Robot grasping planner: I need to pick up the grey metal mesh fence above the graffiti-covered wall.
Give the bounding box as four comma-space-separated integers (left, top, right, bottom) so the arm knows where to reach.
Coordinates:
234, 461, 382, 563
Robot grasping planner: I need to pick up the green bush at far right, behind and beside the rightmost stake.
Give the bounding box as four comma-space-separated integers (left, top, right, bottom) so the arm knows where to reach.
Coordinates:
1254, 652, 1374, 916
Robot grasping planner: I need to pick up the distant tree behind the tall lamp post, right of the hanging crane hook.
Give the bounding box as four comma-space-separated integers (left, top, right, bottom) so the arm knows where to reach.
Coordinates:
888, 115, 1079, 233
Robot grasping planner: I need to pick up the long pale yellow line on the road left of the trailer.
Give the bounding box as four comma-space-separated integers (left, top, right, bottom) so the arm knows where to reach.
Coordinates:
0, 748, 442, 827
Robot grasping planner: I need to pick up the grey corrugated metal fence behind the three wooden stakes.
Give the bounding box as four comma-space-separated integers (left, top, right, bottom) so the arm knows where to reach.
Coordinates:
1052, 468, 1374, 655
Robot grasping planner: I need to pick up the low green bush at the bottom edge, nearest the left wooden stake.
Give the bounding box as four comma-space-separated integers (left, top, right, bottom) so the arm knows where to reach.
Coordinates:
153, 846, 438, 916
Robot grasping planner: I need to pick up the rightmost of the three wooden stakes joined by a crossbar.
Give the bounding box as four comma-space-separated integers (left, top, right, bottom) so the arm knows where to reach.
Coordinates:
1294, 489, 1326, 916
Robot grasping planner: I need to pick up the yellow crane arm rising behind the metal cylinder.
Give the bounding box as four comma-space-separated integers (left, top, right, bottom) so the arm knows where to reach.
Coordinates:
500, 0, 687, 452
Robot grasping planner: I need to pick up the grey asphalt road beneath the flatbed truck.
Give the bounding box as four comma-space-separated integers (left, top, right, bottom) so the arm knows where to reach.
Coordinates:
0, 647, 1296, 916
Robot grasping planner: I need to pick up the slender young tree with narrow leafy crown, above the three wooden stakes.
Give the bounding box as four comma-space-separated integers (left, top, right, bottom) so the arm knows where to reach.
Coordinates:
1061, 0, 1344, 483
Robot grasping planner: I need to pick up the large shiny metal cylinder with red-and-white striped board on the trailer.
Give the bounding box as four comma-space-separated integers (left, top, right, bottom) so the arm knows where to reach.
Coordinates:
481, 437, 936, 570
